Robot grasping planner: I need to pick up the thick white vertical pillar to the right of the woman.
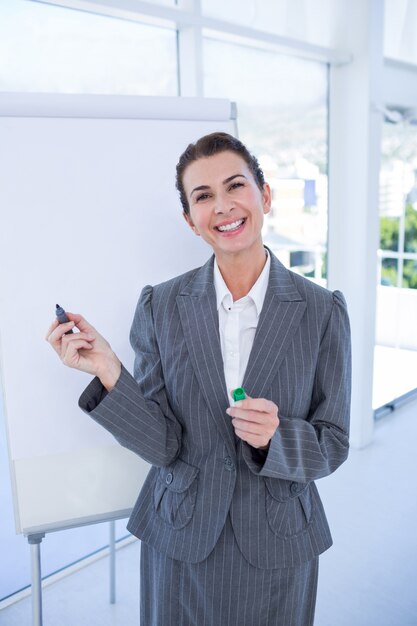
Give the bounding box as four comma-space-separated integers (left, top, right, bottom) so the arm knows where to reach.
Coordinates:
328, 0, 384, 447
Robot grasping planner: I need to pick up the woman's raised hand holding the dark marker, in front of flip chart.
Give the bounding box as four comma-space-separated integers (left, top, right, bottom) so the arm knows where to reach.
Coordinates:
45, 311, 122, 391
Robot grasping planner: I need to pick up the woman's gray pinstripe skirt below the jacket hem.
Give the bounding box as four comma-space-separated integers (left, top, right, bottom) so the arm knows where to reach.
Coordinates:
140, 517, 319, 626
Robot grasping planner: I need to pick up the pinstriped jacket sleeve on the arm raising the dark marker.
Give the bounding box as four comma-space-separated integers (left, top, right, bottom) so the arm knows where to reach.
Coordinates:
79, 286, 181, 467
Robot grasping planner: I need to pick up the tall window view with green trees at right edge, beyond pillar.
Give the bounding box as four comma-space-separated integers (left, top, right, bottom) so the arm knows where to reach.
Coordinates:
373, 121, 417, 408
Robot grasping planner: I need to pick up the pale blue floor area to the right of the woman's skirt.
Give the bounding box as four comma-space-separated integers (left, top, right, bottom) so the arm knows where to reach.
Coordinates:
315, 394, 417, 626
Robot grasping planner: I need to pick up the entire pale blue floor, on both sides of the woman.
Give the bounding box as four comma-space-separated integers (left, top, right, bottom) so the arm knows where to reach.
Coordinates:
0, 403, 417, 626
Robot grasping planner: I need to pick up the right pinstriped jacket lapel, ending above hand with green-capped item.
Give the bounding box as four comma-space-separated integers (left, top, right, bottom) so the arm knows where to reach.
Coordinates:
243, 251, 306, 398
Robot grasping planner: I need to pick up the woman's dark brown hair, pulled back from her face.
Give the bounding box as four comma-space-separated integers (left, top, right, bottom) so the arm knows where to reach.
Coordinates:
176, 132, 265, 215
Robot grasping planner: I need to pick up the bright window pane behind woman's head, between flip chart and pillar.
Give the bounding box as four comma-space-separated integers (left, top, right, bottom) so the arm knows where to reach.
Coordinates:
204, 38, 328, 285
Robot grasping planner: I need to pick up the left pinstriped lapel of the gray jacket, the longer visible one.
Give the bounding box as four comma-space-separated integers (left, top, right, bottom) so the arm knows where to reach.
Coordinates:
177, 257, 236, 457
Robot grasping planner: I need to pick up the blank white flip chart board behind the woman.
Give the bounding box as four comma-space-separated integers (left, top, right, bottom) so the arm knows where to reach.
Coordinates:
0, 94, 235, 534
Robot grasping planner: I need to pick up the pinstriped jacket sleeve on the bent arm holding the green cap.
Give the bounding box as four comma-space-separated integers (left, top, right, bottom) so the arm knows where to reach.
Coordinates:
242, 291, 351, 483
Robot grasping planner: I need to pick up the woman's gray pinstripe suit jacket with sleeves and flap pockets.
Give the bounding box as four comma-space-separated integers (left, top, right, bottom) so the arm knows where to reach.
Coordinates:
79, 247, 350, 569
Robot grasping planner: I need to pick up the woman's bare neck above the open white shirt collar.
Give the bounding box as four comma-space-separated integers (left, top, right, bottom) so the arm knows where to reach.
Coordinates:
216, 241, 266, 302
